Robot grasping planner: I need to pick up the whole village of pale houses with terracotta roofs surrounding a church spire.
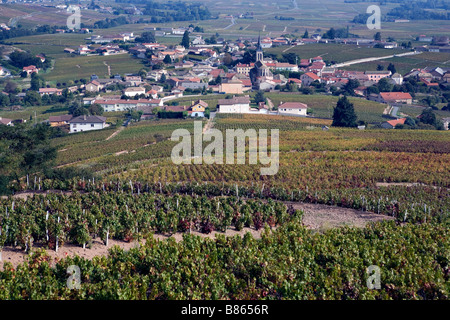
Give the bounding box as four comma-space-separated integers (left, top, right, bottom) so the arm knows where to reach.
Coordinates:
0, 25, 450, 133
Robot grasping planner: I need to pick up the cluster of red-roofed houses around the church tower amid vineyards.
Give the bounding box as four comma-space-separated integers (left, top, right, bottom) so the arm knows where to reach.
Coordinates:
0, 28, 450, 133
